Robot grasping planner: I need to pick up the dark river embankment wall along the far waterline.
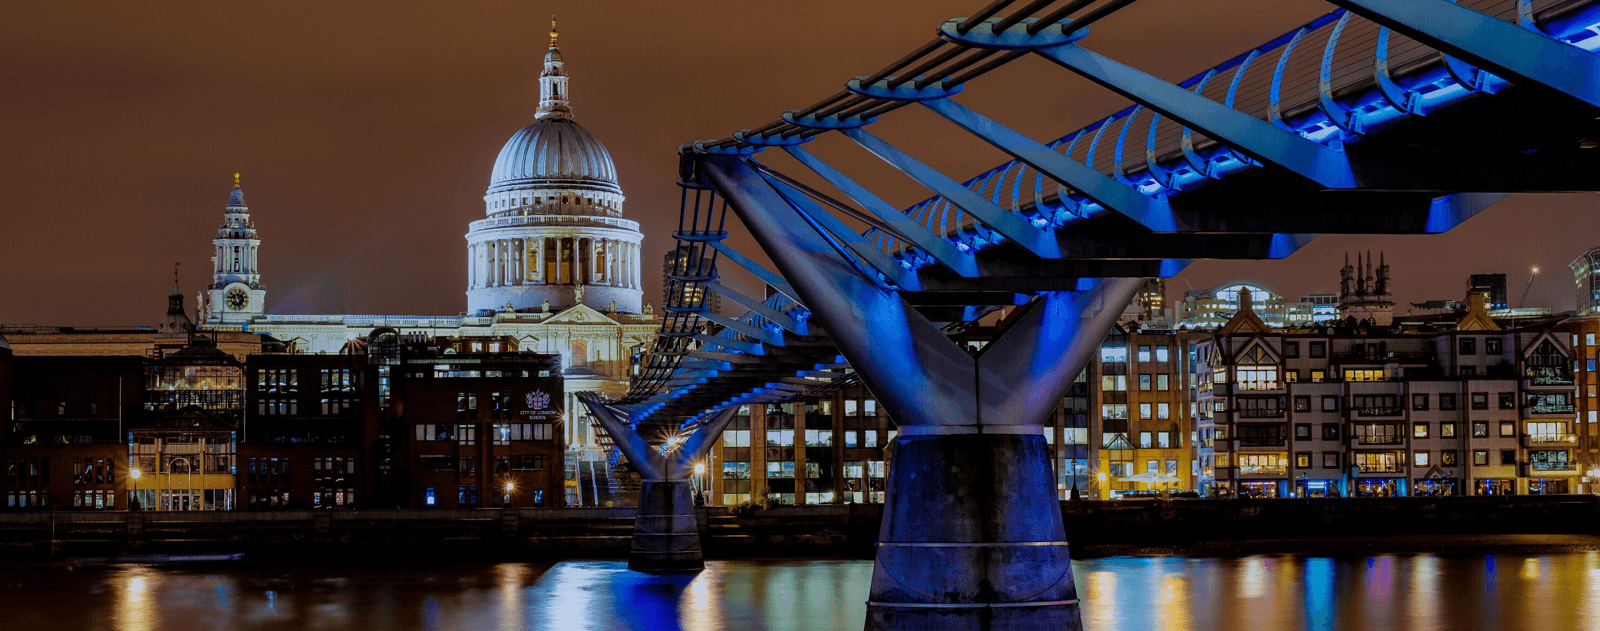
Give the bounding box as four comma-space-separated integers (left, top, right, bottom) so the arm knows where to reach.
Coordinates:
0, 495, 1600, 562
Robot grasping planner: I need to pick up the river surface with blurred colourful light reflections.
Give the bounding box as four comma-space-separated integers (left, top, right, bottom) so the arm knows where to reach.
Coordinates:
0, 551, 1600, 631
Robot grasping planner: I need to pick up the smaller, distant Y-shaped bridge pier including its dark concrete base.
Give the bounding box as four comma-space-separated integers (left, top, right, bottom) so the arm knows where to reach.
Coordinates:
584, 400, 739, 572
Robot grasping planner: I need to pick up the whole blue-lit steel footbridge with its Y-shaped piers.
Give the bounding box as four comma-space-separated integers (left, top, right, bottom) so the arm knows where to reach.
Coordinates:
584, 0, 1600, 629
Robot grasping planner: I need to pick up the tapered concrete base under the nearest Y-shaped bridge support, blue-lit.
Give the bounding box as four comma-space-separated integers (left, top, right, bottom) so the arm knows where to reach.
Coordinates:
866, 426, 1082, 631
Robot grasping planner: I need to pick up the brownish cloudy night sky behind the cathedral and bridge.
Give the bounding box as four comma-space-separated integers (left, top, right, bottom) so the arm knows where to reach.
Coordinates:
0, 0, 1600, 325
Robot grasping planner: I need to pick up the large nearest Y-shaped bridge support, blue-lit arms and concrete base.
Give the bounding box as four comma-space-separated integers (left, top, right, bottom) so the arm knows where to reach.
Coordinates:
696, 155, 1142, 629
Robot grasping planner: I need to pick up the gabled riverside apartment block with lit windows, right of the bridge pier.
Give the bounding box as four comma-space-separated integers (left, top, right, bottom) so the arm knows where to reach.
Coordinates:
1195, 286, 1579, 498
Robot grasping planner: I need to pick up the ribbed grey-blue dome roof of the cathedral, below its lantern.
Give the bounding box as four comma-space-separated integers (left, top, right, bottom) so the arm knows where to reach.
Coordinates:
488, 115, 622, 194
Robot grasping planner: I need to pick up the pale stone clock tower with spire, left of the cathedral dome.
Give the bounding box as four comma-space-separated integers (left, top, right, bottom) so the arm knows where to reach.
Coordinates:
203, 171, 267, 327
